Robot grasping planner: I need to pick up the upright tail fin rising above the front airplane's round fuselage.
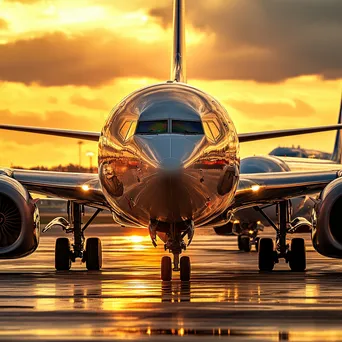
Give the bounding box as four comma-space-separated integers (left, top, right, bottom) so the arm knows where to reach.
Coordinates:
171, 0, 186, 83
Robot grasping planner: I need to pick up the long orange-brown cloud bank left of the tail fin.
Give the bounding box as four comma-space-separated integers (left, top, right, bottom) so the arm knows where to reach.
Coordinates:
0, 30, 169, 86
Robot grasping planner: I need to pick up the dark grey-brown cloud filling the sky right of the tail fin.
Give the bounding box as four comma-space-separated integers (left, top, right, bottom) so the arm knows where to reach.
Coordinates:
149, 0, 342, 83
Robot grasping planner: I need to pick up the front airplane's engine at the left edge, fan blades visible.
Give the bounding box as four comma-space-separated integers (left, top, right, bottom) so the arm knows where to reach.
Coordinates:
0, 171, 40, 259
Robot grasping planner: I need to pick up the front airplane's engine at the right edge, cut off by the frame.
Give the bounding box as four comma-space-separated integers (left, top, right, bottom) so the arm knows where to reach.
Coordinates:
312, 178, 342, 258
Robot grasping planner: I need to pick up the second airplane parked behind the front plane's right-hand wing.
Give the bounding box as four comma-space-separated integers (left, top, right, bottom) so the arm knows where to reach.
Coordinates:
214, 97, 342, 252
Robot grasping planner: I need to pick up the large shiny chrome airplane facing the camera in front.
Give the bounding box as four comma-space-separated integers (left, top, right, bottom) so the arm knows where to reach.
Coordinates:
0, 0, 342, 281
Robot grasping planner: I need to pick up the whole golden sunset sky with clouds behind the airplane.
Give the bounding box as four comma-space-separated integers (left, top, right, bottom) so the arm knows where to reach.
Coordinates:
0, 0, 342, 167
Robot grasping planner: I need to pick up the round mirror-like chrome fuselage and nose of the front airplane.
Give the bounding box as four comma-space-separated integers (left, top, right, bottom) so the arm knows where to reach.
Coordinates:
99, 83, 240, 227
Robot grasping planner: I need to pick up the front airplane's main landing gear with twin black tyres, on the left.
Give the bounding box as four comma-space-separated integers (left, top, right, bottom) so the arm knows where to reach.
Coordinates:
43, 202, 102, 271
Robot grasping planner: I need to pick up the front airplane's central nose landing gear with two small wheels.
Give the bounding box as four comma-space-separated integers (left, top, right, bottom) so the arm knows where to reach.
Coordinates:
160, 221, 195, 281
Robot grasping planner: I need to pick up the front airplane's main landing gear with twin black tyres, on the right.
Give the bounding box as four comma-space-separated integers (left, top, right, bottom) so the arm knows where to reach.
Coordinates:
255, 201, 306, 272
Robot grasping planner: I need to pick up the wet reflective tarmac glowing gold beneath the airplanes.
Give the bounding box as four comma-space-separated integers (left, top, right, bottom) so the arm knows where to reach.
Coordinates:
0, 226, 342, 341
